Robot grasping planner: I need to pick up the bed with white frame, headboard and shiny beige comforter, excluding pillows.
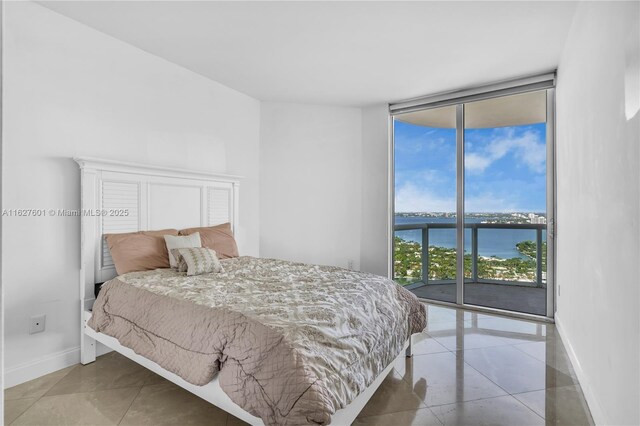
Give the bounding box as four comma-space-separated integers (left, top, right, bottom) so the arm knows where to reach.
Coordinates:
76, 159, 425, 425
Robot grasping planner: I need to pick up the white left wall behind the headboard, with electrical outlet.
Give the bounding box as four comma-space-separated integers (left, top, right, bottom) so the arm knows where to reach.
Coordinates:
2, 2, 260, 386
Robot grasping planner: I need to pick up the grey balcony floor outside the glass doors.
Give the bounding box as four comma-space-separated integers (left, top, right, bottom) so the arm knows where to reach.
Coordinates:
411, 283, 547, 315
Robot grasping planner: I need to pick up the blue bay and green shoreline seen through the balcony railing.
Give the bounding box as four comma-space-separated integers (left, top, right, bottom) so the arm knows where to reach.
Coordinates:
394, 212, 546, 286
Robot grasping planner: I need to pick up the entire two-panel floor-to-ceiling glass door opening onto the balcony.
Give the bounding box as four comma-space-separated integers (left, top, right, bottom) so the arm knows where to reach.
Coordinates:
392, 75, 554, 316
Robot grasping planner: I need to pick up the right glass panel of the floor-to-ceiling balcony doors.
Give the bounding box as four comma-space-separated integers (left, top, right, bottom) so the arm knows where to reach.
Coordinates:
464, 91, 547, 315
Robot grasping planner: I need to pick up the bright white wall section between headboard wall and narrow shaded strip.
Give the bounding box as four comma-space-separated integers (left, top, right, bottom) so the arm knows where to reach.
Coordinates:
260, 102, 362, 269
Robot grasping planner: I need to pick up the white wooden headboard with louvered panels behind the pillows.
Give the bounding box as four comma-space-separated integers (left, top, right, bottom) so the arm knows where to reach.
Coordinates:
74, 158, 239, 310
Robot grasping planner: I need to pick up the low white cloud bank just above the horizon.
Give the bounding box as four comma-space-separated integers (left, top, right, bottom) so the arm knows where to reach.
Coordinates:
395, 183, 520, 213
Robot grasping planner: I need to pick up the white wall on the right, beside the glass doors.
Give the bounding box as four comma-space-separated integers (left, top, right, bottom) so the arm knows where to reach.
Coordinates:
556, 2, 640, 425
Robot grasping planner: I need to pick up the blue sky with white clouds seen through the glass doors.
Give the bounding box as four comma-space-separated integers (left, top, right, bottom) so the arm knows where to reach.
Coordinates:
394, 120, 546, 213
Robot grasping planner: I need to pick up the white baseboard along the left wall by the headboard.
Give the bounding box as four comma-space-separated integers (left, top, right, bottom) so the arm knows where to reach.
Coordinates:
4, 344, 112, 389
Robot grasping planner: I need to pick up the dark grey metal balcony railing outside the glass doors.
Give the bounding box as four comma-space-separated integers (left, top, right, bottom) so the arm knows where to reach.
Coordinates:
394, 223, 547, 289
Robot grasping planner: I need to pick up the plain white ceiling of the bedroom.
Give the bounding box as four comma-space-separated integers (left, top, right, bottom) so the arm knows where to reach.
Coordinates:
39, 1, 575, 106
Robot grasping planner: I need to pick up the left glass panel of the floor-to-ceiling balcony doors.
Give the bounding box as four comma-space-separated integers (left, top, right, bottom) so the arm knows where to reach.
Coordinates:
393, 106, 457, 303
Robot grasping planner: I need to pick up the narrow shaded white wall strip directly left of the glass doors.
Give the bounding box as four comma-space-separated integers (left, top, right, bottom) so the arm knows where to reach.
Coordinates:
360, 105, 390, 277
